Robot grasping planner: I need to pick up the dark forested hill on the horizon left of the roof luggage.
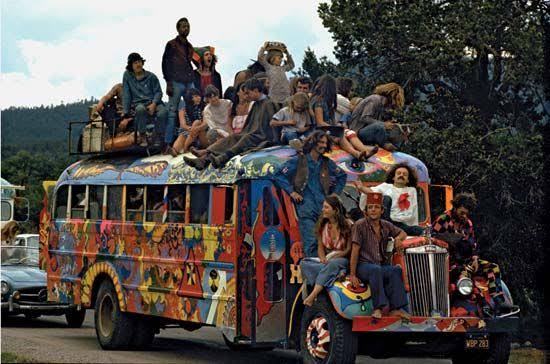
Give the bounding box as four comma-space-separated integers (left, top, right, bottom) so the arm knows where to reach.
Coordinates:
1, 99, 97, 159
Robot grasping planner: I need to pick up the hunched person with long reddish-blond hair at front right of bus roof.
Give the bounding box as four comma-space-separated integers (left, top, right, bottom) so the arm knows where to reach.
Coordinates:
349, 82, 405, 151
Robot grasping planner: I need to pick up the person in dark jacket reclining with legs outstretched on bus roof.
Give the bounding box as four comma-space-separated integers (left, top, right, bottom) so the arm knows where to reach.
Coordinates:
183, 78, 280, 169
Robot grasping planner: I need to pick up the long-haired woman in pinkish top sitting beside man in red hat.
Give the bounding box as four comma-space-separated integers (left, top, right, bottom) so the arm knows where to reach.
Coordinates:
300, 194, 351, 306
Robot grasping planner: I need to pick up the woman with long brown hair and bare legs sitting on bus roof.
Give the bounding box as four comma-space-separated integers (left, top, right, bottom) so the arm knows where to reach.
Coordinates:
311, 75, 378, 162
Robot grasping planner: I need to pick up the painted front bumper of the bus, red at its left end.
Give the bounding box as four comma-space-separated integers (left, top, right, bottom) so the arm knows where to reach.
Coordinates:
352, 316, 519, 334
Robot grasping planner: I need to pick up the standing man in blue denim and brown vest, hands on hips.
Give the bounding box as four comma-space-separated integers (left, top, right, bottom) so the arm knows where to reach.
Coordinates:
273, 130, 347, 257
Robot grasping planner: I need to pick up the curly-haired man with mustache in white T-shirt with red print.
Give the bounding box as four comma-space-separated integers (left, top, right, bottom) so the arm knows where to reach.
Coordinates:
357, 163, 424, 236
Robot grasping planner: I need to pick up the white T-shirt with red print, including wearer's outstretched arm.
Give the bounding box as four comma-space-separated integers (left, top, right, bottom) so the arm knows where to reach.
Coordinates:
359, 182, 418, 226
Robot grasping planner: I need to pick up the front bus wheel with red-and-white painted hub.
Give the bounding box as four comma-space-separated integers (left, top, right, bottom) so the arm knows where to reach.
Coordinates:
300, 294, 357, 364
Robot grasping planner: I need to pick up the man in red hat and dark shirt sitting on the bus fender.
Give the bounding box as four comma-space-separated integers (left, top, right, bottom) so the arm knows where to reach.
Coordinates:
349, 192, 410, 319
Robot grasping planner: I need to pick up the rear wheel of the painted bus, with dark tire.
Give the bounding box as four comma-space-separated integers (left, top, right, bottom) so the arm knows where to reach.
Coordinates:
94, 280, 135, 350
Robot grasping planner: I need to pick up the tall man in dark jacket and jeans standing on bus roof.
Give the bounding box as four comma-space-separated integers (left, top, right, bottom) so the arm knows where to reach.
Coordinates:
162, 18, 199, 152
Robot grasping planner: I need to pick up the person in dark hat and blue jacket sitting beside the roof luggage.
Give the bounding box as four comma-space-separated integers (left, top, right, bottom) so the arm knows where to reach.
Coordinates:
122, 53, 169, 151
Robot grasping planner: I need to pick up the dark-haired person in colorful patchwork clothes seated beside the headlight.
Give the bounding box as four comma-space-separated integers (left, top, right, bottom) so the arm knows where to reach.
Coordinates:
432, 193, 514, 316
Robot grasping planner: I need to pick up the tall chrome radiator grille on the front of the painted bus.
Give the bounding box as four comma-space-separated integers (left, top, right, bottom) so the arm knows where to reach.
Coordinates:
405, 245, 449, 316
